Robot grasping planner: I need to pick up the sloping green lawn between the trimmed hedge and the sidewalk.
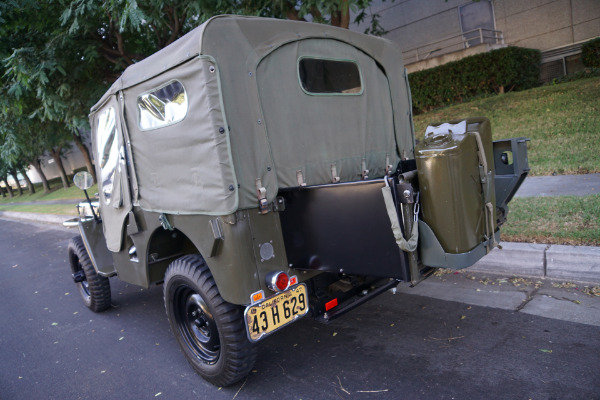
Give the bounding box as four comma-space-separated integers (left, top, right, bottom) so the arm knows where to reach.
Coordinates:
414, 77, 600, 175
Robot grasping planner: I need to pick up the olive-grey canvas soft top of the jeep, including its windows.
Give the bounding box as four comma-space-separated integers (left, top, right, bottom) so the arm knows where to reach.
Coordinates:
90, 16, 414, 215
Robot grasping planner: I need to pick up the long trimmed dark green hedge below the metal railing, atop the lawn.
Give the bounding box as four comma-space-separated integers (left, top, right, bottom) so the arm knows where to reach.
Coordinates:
408, 47, 540, 114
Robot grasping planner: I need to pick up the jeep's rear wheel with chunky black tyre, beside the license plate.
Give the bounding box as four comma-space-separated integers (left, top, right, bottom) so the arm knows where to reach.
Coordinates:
164, 255, 256, 386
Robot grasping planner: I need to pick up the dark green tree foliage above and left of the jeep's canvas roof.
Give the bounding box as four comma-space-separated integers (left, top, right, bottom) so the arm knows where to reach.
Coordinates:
0, 0, 384, 183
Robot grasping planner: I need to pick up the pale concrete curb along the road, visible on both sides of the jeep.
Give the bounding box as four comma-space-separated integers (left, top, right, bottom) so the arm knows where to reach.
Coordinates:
0, 211, 600, 285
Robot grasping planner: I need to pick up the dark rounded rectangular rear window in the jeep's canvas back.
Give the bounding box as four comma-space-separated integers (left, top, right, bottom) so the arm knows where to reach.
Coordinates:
298, 57, 363, 95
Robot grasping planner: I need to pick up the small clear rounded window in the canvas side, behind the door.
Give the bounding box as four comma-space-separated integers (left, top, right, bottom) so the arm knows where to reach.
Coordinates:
137, 81, 188, 131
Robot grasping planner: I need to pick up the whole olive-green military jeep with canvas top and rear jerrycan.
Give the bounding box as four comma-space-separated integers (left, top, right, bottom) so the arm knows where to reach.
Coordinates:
63, 16, 528, 385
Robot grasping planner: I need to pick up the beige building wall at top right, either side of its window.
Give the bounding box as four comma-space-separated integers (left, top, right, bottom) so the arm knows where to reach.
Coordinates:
351, 0, 600, 63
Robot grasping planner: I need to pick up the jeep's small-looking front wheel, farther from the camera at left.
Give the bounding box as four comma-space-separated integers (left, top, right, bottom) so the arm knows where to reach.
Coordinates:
69, 236, 110, 312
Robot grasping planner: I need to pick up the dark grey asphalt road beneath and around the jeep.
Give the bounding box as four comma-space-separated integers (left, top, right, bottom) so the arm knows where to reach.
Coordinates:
0, 220, 600, 400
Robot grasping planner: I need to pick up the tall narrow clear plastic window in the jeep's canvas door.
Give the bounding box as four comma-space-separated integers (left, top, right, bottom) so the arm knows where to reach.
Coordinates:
96, 107, 119, 204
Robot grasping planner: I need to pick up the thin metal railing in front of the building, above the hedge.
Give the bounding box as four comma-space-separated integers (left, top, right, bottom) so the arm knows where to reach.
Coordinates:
402, 28, 504, 64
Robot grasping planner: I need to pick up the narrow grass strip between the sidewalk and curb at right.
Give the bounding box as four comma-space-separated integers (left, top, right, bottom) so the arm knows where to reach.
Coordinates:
501, 195, 600, 246
